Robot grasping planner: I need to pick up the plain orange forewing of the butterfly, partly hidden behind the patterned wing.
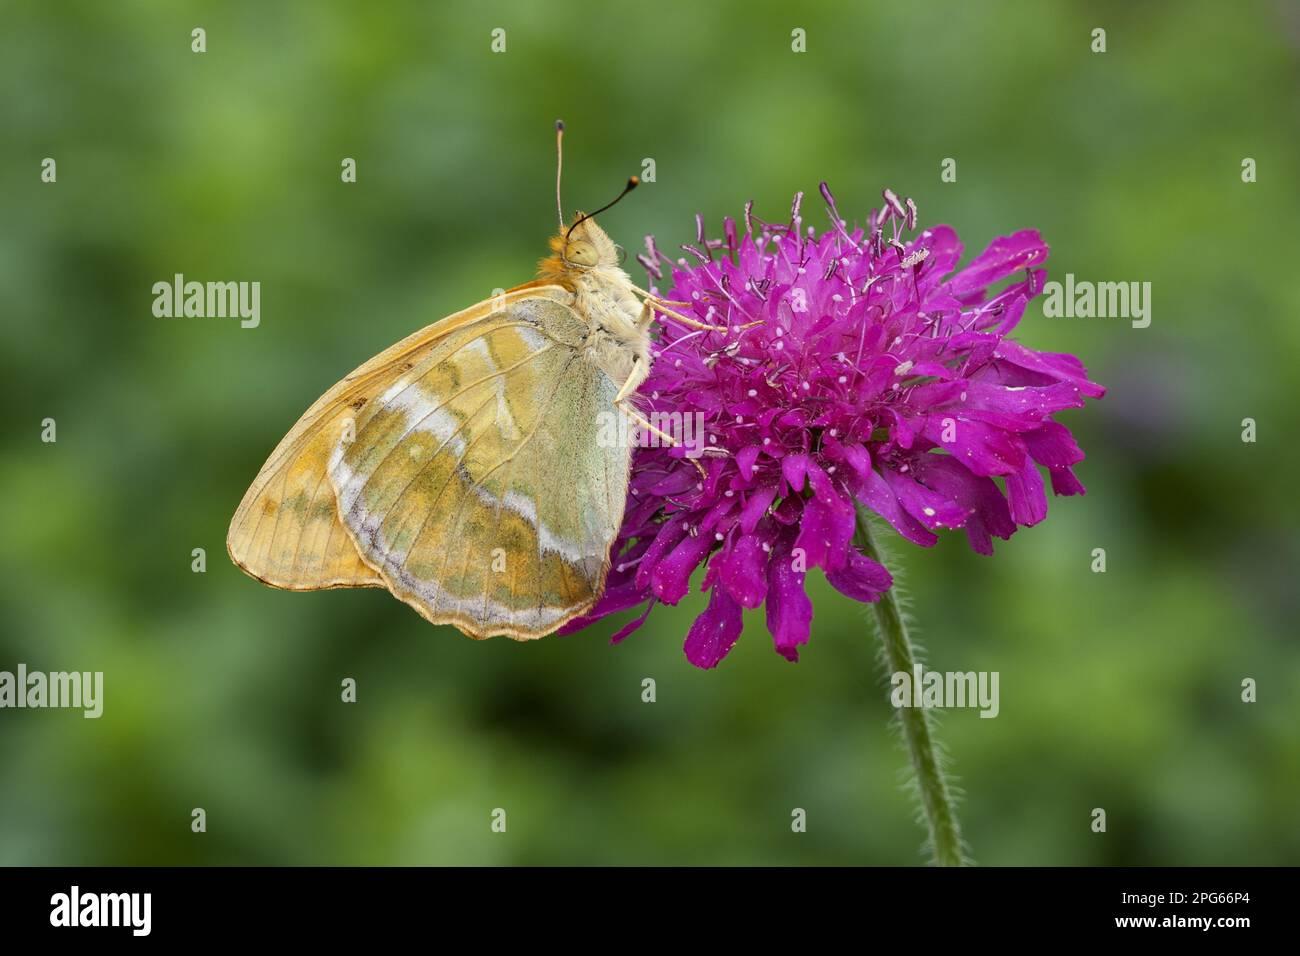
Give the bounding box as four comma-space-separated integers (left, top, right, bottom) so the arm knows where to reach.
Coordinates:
226, 284, 567, 591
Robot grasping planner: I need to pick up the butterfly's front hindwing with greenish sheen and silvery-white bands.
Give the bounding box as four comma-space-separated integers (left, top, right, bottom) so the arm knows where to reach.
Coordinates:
329, 295, 631, 640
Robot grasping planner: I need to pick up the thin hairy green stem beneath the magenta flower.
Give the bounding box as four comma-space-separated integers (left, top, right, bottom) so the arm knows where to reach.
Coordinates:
854, 506, 965, 866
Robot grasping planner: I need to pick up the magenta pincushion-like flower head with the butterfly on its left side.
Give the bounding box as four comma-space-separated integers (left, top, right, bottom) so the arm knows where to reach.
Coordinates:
566, 183, 1105, 667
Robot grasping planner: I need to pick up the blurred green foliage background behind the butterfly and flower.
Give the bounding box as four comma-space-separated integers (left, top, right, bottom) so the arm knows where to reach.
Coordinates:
0, 0, 1300, 865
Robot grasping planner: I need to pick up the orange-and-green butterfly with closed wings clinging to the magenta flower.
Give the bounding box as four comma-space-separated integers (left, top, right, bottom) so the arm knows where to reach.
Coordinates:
226, 122, 727, 640
